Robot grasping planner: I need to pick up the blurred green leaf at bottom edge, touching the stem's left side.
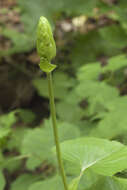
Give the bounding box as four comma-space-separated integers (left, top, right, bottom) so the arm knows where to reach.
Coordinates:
28, 176, 64, 190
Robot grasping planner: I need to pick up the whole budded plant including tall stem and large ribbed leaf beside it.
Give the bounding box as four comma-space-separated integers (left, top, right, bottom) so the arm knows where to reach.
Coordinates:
37, 17, 127, 190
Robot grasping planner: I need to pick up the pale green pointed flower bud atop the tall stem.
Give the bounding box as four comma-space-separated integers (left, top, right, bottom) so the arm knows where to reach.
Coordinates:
37, 16, 56, 72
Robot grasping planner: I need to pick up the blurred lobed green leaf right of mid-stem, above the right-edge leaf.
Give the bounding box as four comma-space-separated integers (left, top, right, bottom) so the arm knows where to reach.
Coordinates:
76, 80, 119, 114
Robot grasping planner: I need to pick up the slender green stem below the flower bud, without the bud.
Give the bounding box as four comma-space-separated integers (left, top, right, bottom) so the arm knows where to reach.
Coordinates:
47, 73, 68, 190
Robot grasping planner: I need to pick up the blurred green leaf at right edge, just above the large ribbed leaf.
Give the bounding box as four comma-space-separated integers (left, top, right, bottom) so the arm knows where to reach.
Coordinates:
90, 96, 127, 138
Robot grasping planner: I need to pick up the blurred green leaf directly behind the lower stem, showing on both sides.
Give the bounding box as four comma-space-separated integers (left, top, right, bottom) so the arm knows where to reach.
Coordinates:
22, 120, 80, 169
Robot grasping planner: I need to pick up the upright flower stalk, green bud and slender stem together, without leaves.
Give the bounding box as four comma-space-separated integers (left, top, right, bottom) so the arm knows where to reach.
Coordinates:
37, 16, 68, 190
